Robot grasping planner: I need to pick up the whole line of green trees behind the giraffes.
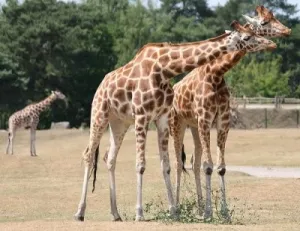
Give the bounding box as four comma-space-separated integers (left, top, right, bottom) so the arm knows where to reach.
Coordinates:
0, 0, 300, 128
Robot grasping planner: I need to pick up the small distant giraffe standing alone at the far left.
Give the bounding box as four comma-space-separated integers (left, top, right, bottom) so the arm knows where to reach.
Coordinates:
6, 91, 68, 156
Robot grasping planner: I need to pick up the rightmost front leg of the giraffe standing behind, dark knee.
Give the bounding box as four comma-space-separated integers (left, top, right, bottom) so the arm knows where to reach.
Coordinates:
217, 111, 230, 219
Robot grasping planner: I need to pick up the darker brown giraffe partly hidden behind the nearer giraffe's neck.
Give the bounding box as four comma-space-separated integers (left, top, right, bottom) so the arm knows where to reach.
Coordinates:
170, 6, 291, 219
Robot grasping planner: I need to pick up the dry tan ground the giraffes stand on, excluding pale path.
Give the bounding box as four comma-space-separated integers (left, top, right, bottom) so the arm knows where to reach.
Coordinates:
0, 129, 300, 231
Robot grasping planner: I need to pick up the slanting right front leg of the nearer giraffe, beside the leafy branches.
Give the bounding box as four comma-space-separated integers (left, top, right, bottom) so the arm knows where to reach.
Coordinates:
156, 114, 176, 216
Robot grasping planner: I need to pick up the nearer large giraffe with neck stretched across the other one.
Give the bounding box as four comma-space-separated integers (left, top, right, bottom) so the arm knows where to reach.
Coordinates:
74, 22, 276, 221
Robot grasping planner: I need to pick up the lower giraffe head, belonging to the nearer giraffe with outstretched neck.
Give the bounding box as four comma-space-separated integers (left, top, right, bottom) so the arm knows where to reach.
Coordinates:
226, 21, 277, 52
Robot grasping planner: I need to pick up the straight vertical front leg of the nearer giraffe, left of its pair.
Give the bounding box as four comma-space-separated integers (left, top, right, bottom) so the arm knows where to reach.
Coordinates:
135, 115, 149, 221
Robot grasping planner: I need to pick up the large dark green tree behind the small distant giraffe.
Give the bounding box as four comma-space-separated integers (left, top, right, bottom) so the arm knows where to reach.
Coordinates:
0, 0, 116, 125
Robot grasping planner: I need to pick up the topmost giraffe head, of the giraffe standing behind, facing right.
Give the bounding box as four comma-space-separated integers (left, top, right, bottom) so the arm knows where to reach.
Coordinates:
243, 6, 291, 37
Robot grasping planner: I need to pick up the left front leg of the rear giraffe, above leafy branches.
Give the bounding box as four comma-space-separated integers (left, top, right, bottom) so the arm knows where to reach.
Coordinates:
198, 117, 213, 220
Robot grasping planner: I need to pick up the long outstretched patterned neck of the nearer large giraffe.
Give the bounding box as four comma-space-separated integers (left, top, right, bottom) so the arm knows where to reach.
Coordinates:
133, 34, 232, 81
